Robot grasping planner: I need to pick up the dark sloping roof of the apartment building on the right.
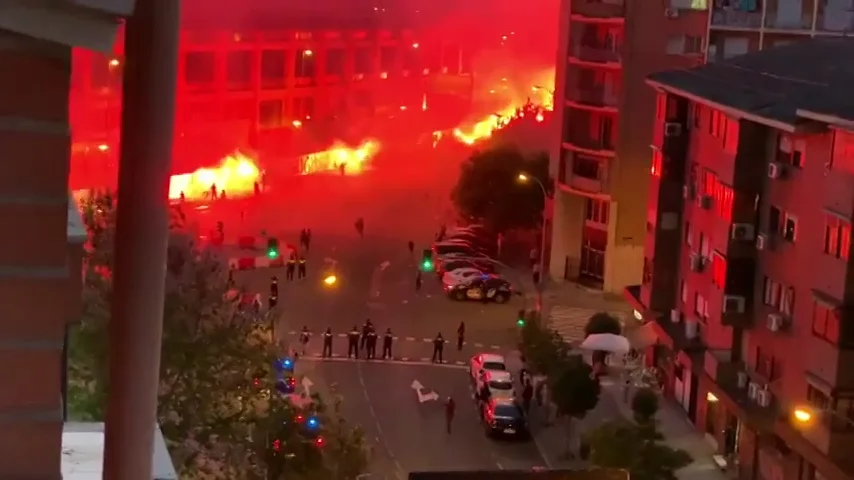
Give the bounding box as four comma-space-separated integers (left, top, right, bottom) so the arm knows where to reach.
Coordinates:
648, 37, 854, 127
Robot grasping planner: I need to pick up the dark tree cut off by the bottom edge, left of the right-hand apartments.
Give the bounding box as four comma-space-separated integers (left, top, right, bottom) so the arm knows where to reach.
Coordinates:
587, 420, 691, 480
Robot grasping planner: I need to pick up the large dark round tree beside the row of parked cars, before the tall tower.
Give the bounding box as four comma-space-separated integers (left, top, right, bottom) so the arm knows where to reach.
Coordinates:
451, 146, 551, 232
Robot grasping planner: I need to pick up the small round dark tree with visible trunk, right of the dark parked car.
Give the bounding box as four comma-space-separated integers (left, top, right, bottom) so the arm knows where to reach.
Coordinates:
547, 355, 601, 451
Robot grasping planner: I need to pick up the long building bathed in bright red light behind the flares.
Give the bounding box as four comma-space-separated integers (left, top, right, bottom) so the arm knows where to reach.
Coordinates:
71, 0, 472, 187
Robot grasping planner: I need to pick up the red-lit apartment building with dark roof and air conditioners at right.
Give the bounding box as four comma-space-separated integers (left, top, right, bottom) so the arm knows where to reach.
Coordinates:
625, 38, 854, 480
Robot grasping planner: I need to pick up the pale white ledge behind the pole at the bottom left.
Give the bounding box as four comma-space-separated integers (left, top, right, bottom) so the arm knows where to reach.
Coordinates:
62, 422, 178, 480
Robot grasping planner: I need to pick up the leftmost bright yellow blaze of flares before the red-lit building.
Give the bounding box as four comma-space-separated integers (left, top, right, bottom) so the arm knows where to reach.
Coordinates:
169, 152, 261, 200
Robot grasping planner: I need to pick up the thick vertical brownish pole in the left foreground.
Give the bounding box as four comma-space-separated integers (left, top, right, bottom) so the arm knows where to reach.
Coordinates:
103, 0, 180, 480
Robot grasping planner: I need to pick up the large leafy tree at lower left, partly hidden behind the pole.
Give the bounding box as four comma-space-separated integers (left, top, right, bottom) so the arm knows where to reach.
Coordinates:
69, 195, 364, 479
